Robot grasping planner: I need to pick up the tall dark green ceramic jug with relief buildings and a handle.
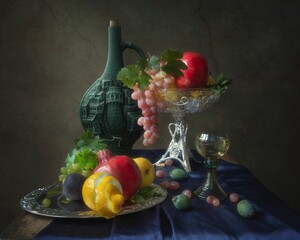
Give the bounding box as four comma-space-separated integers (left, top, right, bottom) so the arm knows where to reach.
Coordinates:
80, 20, 145, 155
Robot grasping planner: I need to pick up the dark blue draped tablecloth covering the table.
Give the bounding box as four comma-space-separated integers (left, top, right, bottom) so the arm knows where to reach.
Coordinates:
35, 150, 300, 240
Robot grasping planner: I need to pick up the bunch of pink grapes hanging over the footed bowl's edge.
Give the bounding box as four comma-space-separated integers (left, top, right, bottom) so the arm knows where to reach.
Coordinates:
131, 69, 174, 146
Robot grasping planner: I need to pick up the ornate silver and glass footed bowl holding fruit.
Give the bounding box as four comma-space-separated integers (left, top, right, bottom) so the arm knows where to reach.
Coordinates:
155, 88, 220, 172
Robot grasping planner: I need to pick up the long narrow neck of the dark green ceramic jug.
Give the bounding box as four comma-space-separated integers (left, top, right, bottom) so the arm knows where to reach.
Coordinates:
104, 24, 124, 77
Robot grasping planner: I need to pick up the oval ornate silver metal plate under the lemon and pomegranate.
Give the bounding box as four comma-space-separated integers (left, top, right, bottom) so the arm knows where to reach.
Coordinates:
20, 184, 168, 218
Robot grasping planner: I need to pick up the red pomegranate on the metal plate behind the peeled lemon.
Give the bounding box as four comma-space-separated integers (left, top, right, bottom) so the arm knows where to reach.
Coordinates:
93, 149, 142, 200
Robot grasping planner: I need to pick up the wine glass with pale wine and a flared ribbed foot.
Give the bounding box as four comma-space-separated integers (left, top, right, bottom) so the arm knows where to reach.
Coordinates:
194, 133, 229, 200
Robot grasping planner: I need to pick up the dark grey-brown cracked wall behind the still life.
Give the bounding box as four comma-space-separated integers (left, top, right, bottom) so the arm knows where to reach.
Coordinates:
0, 0, 300, 230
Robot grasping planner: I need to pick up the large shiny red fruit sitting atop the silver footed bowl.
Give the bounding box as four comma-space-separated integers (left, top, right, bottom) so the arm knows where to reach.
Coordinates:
175, 52, 208, 89
